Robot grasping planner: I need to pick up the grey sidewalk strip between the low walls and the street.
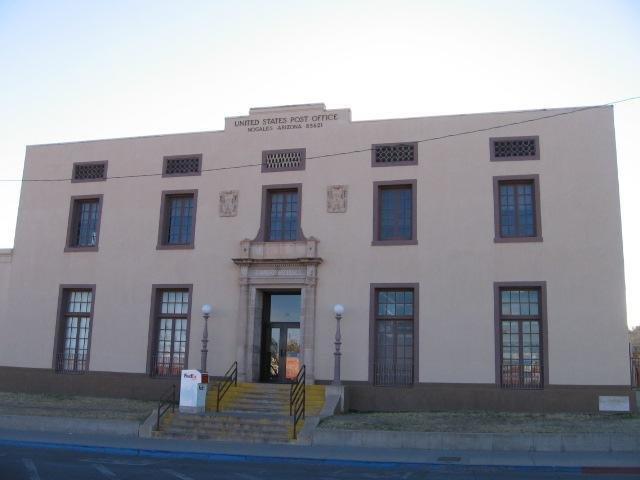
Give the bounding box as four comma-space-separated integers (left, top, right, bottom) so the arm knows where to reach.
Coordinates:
0, 430, 640, 474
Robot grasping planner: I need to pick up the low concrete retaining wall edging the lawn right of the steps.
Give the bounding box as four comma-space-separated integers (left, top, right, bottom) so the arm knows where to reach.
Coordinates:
312, 428, 640, 452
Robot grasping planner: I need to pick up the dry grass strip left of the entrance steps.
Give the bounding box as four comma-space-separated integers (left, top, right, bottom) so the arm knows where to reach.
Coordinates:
0, 392, 157, 421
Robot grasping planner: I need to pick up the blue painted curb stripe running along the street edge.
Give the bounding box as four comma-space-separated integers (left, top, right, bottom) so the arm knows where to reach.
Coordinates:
0, 439, 596, 474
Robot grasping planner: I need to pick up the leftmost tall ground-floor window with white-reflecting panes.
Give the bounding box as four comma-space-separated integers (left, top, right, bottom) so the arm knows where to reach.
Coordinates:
55, 288, 94, 373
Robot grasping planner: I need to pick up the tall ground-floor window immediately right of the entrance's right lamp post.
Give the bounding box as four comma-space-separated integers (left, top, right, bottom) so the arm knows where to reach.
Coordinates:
373, 287, 416, 385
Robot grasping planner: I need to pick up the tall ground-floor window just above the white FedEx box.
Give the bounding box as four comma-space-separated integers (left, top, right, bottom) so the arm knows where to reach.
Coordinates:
151, 288, 190, 377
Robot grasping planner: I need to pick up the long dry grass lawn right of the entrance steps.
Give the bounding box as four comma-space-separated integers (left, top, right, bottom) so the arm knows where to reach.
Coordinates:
320, 411, 640, 433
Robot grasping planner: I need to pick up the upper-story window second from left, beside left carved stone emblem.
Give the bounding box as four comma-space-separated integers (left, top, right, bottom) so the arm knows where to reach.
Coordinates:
158, 190, 198, 249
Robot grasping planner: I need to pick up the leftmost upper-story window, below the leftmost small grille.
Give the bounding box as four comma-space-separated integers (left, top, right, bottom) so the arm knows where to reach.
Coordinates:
65, 195, 102, 251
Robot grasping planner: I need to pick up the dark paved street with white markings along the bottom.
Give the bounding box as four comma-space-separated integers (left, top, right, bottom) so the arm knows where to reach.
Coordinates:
0, 446, 640, 480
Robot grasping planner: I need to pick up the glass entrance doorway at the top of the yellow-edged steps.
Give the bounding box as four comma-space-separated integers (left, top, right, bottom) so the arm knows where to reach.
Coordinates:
260, 290, 302, 383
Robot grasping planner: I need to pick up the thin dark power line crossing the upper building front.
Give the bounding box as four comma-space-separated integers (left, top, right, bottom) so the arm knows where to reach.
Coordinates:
0, 96, 640, 183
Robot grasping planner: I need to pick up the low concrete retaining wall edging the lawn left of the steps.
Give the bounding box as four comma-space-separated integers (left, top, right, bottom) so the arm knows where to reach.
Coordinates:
0, 415, 140, 437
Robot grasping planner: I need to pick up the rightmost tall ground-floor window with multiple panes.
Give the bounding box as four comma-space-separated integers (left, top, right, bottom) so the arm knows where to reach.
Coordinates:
498, 286, 544, 389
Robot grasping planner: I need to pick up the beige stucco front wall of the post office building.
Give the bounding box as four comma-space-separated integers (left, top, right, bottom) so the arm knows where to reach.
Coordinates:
0, 105, 629, 410
